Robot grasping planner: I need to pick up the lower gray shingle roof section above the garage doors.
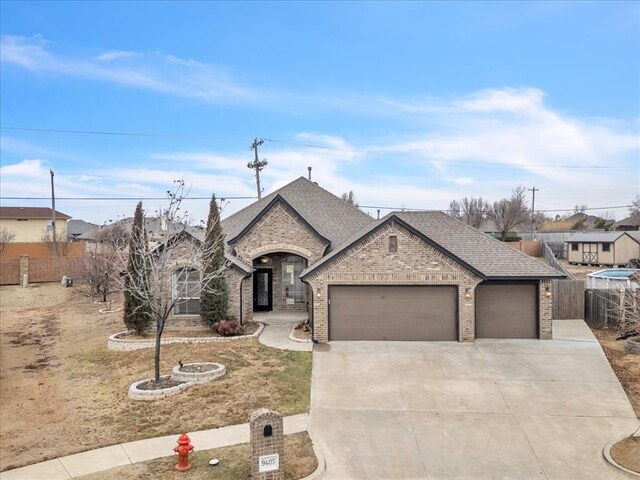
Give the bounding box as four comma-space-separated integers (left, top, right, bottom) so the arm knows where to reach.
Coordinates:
302, 212, 563, 279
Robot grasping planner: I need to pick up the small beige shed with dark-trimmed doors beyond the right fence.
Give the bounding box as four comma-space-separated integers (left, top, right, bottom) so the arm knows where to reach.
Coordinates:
565, 232, 640, 266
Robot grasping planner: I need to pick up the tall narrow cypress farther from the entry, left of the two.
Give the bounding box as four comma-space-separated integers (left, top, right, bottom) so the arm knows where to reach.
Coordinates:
123, 202, 152, 335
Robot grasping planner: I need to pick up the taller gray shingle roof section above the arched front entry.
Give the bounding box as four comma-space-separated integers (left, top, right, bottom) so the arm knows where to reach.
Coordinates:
221, 177, 374, 249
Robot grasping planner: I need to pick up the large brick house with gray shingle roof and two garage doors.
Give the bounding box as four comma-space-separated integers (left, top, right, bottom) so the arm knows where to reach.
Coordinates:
168, 177, 564, 342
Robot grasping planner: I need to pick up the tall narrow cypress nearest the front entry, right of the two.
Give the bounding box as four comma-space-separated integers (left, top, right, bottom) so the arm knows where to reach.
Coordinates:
200, 194, 229, 327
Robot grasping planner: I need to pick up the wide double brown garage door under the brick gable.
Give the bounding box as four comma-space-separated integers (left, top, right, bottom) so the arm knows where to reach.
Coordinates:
329, 286, 458, 340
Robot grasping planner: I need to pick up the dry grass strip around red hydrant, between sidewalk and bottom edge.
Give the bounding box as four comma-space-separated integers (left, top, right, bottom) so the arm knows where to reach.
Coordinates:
78, 432, 318, 480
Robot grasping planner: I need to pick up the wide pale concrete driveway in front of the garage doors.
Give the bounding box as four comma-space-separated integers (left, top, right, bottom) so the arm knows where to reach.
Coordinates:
310, 320, 638, 480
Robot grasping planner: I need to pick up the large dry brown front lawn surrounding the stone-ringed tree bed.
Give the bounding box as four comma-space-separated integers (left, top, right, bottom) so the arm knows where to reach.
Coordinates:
0, 284, 311, 471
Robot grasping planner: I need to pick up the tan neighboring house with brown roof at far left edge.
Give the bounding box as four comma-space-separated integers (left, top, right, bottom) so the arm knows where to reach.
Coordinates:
0, 207, 71, 242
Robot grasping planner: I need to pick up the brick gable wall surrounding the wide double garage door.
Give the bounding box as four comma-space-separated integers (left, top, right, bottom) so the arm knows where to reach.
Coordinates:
305, 222, 481, 342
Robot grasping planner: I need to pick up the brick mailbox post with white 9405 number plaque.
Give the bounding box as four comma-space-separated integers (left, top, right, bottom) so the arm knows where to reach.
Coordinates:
249, 408, 284, 480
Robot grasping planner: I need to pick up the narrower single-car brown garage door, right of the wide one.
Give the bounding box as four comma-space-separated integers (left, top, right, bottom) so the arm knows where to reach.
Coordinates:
476, 284, 538, 338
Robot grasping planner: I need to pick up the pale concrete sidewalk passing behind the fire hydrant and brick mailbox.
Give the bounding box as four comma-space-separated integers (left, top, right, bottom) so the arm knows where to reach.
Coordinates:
0, 413, 308, 480
